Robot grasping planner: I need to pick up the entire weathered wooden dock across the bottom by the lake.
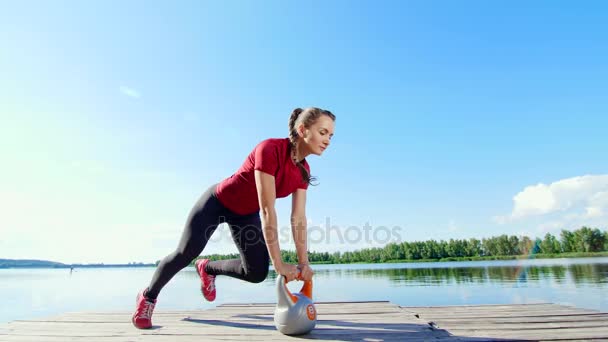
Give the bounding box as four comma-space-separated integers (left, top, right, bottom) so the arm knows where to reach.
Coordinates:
0, 301, 608, 342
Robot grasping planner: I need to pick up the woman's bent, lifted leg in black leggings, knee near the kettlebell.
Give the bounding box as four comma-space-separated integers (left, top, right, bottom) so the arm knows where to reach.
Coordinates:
205, 213, 270, 283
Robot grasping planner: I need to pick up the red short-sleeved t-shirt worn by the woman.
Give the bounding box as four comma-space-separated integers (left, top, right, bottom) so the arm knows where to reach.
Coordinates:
216, 138, 310, 215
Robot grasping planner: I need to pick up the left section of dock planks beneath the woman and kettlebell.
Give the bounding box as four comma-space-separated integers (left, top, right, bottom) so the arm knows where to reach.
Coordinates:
3, 302, 449, 342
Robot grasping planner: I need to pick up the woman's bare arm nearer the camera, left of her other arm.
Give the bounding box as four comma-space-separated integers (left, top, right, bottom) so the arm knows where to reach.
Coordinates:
254, 170, 297, 281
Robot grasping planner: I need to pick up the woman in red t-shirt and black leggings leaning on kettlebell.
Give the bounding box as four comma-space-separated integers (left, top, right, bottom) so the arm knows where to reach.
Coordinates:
132, 107, 336, 329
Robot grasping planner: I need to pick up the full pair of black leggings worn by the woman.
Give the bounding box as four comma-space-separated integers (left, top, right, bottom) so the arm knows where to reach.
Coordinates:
147, 185, 270, 298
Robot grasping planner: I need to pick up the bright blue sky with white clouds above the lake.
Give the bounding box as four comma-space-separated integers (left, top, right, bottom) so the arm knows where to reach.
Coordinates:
0, 1, 608, 262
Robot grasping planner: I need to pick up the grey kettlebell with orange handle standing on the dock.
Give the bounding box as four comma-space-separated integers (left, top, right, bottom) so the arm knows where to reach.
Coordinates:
274, 275, 317, 335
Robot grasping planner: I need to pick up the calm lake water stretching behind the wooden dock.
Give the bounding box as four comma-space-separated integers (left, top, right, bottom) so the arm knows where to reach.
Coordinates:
0, 258, 608, 323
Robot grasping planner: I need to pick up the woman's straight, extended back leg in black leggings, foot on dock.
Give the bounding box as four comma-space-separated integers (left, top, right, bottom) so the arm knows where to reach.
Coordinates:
146, 185, 224, 299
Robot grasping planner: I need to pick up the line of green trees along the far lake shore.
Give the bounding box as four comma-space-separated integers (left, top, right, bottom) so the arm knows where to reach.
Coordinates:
197, 227, 608, 264
